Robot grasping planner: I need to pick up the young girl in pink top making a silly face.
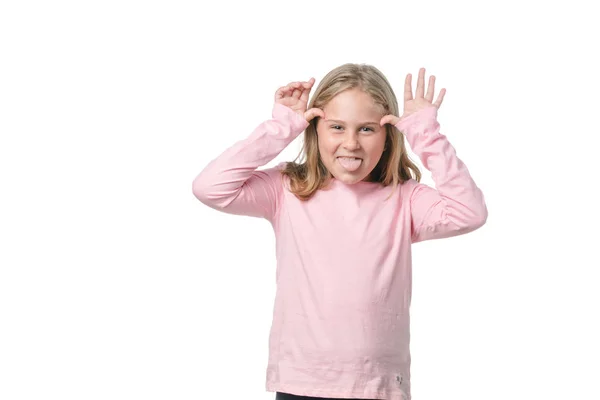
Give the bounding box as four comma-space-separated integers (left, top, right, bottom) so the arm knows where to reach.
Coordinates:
193, 64, 487, 400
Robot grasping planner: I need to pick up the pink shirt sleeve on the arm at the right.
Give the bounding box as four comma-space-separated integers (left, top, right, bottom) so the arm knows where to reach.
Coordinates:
396, 105, 488, 243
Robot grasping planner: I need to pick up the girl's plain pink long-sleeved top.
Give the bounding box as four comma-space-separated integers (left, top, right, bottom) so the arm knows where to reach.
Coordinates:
193, 103, 487, 400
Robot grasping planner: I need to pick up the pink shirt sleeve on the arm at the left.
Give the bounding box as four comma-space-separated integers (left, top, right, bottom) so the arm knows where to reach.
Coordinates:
192, 103, 309, 222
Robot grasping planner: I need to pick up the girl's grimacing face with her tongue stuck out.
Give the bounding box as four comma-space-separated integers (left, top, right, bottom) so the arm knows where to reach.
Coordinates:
317, 89, 386, 184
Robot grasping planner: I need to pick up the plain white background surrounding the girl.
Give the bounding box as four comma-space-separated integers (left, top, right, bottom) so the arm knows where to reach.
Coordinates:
0, 0, 600, 400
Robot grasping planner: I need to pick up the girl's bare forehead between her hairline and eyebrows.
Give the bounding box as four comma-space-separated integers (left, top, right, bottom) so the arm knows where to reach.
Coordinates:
323, 89, 382, 122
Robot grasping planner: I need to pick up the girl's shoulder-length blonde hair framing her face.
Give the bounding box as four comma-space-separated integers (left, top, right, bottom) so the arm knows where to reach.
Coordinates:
281, 63, 421, 200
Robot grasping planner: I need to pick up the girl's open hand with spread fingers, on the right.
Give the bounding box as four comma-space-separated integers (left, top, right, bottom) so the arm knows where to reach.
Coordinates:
379, 68, 446, 126
